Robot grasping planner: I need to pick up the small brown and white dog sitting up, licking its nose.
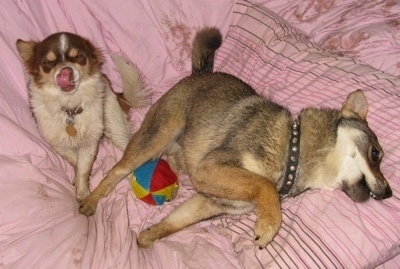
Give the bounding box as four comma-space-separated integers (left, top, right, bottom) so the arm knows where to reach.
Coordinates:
16, 32, 149, 201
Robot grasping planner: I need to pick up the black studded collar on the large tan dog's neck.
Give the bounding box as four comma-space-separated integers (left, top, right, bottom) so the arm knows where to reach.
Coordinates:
279, 119, 300, 199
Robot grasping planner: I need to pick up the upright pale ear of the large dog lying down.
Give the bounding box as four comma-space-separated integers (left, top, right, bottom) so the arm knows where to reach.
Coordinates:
340, 90, 368, 120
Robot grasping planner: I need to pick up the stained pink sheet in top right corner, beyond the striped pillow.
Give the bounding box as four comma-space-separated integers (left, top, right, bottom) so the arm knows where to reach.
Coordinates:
260, 0, 400, 76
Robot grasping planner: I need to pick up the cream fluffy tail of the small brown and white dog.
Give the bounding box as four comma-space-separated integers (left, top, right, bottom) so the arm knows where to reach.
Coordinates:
111, 53, 151, 107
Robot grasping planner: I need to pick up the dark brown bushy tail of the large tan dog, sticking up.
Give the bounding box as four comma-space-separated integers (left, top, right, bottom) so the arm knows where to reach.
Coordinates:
192, 27, 222, 74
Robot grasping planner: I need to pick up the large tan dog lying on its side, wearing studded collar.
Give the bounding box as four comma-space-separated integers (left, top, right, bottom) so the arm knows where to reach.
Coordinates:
80, 28, 392, 247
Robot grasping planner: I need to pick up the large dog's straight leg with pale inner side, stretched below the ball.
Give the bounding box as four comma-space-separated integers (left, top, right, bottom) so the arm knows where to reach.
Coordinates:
137, 194, 226, 248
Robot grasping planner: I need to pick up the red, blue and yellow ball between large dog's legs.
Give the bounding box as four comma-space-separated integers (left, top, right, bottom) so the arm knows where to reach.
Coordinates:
131, 159, 179, 205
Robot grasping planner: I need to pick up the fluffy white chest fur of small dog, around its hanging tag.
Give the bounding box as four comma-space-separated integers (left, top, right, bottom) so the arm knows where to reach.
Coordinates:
30, 76, 105, 148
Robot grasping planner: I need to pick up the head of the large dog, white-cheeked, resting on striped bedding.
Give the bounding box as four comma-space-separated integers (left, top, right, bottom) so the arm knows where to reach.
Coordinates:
336, 90, 392, 202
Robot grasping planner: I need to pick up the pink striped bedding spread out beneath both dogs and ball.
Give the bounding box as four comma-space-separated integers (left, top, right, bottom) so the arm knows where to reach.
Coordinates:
0, 0, 400, 268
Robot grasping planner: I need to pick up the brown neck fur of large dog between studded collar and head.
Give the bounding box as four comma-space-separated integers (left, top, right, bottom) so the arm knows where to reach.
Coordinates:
280, 108, 340, 196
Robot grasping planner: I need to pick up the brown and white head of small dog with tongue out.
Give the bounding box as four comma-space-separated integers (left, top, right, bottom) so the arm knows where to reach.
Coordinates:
16, 32, 103, 94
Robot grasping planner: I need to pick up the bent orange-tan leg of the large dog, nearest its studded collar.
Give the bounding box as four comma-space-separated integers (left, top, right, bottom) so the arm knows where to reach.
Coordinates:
191, 155, 282, 247
